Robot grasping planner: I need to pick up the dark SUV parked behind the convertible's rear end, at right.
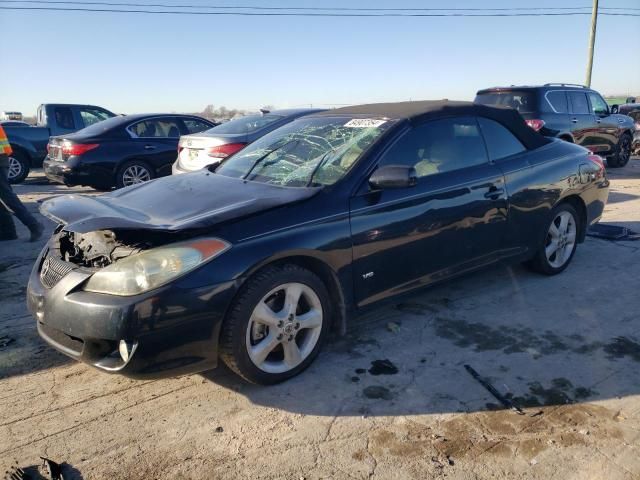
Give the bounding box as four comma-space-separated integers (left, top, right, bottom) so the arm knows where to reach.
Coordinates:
475, 83, 634, 167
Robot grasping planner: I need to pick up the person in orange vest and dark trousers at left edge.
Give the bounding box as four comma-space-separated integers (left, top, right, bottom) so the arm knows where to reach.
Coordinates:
0, 125, 44, 242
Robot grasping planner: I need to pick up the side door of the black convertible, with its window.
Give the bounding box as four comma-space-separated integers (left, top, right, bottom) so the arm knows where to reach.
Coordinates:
350, 117, 507, 306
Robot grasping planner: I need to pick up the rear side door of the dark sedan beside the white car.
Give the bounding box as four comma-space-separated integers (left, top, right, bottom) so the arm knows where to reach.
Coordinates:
127, 116, 180, 177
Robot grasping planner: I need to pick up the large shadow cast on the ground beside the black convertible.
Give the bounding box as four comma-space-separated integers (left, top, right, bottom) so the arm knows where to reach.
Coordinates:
203, 255, 640, 416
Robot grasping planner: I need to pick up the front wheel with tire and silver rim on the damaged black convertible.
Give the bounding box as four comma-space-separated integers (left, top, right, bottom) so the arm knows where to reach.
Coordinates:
219, 265, 332, 385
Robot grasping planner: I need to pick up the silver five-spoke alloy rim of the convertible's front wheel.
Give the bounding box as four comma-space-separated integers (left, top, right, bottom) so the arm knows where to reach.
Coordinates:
246, 283, 324, 373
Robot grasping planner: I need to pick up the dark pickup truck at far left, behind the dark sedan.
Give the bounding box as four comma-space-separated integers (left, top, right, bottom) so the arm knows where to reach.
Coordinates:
3, 103, 115, 183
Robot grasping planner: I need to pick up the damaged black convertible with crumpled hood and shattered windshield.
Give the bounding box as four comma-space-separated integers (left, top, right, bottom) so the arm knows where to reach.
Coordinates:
27, 101, 609, 384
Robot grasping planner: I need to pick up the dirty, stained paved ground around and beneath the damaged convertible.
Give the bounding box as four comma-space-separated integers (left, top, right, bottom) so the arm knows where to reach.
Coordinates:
0, 162, 640, 480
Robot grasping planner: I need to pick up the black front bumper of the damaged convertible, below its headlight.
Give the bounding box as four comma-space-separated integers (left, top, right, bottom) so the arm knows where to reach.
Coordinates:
27, 246, 237, 378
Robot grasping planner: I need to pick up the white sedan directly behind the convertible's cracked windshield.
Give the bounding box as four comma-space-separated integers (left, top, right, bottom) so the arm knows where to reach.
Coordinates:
172, 108, 323, 175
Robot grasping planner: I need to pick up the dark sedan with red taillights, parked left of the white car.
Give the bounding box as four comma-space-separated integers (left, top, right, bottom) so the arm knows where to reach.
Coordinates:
43, 114, 215, 190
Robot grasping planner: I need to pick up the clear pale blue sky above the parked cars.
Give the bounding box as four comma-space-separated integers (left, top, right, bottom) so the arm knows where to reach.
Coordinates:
0, 0, 640, 114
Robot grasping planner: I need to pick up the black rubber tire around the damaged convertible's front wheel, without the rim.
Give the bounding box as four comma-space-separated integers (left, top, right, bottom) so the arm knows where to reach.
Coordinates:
219, 264, 333, 385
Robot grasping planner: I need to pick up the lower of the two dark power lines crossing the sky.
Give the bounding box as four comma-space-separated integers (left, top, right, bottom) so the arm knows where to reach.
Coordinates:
0, 3, 640, 18
